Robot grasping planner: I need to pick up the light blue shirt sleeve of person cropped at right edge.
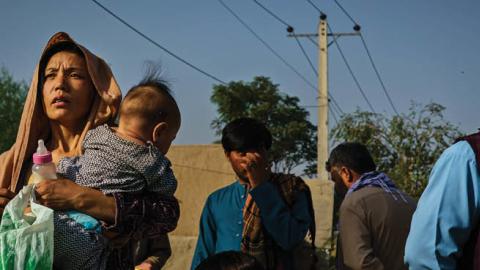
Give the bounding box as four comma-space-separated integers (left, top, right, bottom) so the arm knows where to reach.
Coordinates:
405, 141, 480, 269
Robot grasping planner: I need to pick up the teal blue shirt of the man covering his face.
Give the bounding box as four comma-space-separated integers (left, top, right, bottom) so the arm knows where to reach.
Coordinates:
191, 178, 310, 269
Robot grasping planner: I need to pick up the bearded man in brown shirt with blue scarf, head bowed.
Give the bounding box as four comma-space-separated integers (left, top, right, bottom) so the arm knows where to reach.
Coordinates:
326, 143, 415, 270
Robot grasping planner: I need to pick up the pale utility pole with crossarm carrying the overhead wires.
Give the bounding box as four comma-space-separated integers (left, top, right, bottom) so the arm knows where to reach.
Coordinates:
287, 13, 360, 253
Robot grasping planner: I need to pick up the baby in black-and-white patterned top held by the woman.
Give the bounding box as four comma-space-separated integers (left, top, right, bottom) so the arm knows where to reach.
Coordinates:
54, 75, 181, 269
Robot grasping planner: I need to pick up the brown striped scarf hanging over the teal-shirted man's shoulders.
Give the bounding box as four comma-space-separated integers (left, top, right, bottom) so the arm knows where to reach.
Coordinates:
241, 173, 315, 269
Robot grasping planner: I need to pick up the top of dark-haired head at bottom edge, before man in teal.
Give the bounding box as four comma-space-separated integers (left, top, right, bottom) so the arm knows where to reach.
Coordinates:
195, 251, 263, 270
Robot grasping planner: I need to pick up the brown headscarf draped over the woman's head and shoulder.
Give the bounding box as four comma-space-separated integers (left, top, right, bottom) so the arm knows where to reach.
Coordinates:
0, 32, 122, 192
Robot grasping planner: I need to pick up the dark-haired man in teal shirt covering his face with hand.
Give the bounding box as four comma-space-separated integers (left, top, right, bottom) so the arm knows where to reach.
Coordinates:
192, 118, 315, 270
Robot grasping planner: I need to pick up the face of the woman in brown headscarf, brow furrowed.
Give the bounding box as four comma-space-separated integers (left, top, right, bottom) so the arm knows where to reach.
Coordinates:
42, 51, 95, 127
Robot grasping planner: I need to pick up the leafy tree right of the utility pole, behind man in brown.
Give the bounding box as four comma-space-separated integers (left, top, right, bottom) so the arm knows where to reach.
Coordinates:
331, 103, 461, 197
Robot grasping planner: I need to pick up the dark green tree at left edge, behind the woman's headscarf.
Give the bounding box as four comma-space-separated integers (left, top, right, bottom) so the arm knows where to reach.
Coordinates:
0, 67, 28, 153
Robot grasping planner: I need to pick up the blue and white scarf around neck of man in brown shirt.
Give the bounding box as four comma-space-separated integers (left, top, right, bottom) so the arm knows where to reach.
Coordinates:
346, 171, 407, 202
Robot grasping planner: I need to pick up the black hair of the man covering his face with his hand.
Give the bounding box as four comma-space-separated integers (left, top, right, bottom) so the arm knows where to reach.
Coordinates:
222, 117, 272, 152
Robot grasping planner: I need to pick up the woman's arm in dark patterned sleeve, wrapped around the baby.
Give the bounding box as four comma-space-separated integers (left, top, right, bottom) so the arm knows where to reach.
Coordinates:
36, 179, 180, 239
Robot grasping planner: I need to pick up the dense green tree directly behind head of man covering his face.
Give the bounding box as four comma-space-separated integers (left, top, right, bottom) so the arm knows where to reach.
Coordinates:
211, 76, 317, 176
